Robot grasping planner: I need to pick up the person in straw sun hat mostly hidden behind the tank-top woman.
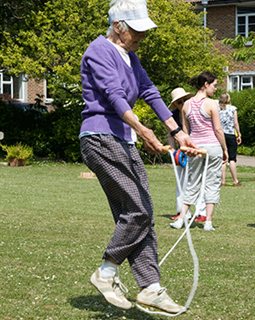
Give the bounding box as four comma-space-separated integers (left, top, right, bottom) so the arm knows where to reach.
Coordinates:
168, 87, 206, 222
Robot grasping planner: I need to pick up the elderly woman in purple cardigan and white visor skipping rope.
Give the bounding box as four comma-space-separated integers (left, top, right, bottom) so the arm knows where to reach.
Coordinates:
79, 0, 197, 313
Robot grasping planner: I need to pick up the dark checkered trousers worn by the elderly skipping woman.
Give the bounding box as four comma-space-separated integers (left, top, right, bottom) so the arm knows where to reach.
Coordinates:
81, 135, 160, 288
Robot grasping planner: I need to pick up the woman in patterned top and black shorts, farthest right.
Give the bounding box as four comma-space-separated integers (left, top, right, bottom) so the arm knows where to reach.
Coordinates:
219, 93, 242, 186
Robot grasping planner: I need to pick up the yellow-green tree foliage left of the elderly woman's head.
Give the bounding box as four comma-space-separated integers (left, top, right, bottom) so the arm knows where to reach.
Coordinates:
0, 0, 108, 103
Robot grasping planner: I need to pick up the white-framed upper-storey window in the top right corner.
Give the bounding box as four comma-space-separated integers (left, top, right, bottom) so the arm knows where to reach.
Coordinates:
236, 7, 255, 37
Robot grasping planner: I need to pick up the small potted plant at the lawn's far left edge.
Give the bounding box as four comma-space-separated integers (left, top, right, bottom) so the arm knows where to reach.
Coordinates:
1, 143, 33, 167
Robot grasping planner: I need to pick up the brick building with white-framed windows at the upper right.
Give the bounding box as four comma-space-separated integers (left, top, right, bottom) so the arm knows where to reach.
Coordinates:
186, 0, 255, 91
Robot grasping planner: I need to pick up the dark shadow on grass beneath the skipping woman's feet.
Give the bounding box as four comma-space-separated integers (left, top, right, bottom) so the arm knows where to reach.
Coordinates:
67, 295, 155, 320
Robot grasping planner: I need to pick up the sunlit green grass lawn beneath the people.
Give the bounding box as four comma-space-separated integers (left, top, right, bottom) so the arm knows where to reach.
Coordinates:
0, 163, 255, 320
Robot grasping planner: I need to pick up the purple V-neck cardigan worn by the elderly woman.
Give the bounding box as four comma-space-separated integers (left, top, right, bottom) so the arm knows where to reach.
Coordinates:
80, 36, 172, 141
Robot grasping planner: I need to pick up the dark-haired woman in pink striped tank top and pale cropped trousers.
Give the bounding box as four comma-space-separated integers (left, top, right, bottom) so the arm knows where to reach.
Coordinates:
170, 71, 228, 231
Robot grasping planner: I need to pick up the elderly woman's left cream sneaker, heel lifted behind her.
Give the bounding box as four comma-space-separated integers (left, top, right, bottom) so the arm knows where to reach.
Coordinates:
90, 269, 132, 309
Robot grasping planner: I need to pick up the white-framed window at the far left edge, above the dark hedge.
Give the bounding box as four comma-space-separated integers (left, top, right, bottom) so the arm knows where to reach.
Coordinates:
0, 71, 24, 101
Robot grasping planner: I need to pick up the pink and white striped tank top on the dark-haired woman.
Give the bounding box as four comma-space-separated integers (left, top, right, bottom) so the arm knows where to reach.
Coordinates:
187, 98, 220, 146
